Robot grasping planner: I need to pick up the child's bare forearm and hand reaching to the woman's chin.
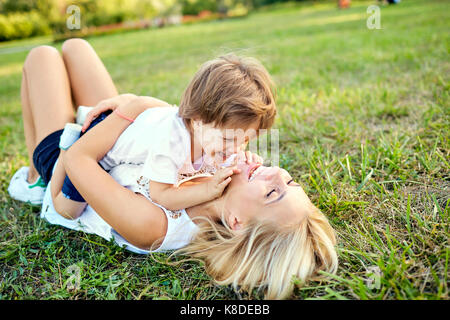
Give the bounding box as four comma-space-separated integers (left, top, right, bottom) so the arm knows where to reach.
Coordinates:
149, 167, 240, 210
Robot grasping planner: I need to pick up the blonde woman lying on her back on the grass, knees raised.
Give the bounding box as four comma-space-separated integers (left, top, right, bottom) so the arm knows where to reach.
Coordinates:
8, 39, 337, 299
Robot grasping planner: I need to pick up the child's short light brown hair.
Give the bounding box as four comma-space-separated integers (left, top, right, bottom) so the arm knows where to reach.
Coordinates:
179, 53, 277, 129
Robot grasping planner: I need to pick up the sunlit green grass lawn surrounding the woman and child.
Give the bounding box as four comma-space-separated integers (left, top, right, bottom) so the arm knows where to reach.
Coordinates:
0, 0, 450, 299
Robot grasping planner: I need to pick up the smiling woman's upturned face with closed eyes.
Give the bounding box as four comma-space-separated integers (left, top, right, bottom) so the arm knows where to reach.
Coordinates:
224, 156, 313, 230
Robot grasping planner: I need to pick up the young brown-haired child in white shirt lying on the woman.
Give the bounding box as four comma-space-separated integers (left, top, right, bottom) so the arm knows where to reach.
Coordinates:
54, 54, 276, 218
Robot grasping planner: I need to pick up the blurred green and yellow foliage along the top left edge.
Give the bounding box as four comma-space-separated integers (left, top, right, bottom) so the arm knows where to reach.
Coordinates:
0, 0, 301, 41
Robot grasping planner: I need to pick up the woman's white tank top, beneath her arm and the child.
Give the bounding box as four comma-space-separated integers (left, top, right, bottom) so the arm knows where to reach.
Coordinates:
40, 163, 198, 254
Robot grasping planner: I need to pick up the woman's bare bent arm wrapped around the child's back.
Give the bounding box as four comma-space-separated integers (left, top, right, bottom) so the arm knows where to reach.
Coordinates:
64, 99, 167, 248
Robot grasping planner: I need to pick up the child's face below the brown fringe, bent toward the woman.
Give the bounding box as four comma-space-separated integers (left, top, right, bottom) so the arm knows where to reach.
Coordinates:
193, 121, 258, 164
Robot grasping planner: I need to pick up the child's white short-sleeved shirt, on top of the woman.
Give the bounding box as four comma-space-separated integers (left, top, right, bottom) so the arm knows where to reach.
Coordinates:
99, 105, 215, 184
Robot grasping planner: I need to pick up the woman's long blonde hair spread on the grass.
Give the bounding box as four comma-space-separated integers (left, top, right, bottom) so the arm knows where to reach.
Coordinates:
174, 206, 338, 299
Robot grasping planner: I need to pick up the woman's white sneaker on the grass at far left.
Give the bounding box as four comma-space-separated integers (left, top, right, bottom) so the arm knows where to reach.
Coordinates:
8, 167, 47, 205
